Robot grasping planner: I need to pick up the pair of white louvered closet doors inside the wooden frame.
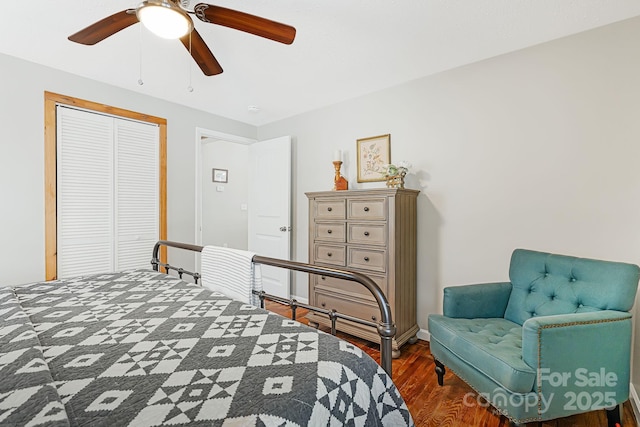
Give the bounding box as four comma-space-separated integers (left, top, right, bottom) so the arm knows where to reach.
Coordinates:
56, 105, 160, 277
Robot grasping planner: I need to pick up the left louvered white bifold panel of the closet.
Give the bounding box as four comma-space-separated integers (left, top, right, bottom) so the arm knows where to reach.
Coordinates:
56, 106, 114, 277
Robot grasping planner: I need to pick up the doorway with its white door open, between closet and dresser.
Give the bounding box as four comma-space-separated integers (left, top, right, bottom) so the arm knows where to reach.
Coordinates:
195, 128, 292, 298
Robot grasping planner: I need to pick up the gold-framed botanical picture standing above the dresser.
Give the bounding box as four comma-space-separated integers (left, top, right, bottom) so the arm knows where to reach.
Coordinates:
357, 134, 391, 182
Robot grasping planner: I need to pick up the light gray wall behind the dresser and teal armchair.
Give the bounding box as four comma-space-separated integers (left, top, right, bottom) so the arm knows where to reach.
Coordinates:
258, 19, 640, 402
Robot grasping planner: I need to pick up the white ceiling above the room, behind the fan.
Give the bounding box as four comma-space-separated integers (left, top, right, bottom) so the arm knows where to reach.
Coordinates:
0, 0, 640, 126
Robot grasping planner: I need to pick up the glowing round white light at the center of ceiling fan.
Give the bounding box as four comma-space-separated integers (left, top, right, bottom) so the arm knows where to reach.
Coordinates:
136, 0, 193, 39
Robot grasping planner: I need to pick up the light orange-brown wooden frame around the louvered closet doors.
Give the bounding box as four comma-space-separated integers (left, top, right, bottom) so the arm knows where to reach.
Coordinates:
44, 91, 167, 280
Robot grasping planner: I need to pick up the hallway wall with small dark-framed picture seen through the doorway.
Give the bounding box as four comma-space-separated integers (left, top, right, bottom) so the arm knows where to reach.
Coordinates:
202, 138, 249, 250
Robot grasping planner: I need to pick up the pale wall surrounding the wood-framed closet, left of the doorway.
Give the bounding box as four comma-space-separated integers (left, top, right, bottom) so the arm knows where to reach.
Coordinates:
0, 54, 256, 286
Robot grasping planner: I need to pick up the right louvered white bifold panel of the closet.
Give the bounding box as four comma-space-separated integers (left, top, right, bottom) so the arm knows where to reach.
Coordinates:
115, 120, 160, 271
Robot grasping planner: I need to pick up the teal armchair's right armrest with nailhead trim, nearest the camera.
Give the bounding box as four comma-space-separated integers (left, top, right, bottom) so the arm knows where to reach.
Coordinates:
522, 310, 632, 422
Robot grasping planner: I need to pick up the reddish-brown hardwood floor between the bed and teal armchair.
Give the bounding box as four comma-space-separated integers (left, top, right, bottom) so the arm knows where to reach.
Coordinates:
267, 302, 637, 427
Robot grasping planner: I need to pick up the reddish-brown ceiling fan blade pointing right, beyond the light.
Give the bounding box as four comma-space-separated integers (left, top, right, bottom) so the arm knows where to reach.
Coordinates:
193, 3, 296, 44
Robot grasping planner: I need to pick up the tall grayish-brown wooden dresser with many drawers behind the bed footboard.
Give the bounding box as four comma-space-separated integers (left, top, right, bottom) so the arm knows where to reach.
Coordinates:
306, 188, 419, 357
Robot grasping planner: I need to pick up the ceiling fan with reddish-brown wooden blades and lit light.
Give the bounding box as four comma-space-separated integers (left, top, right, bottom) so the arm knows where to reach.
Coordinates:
69, 0, 296, 76
